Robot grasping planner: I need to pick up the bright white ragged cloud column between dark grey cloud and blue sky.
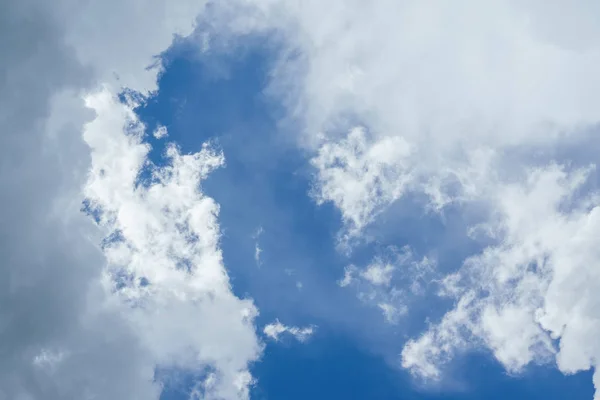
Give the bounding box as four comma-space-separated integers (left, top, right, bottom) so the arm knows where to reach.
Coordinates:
84, 90, 260, 399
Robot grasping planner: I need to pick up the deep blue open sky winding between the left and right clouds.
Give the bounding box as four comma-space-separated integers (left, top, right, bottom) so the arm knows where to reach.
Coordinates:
124, 30, 593, 400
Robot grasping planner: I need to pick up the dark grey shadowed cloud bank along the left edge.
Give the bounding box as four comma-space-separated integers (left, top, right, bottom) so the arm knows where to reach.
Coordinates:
0, 2, 159, 399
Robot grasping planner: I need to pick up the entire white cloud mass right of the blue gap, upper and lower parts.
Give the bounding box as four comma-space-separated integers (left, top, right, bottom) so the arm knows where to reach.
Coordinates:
193, 0, 600, 398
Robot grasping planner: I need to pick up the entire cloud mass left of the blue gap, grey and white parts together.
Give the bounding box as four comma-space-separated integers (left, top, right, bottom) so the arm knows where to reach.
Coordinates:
0, 0, 260, 399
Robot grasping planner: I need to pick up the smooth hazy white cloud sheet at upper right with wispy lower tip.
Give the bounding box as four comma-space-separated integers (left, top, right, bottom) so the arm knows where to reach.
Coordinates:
215, 0, 600, 236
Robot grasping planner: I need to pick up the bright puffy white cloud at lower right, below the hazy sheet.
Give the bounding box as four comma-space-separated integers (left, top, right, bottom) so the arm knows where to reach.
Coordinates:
403, 165, 600, 390
